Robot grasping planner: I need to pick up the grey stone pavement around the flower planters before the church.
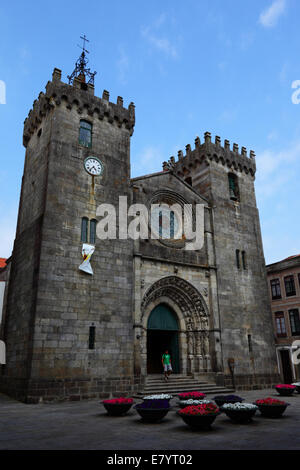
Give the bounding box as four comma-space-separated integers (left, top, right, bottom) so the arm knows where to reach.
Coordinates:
0, 390, 300, 450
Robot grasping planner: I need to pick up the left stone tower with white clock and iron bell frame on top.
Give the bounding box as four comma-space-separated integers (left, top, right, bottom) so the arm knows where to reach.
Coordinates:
0, 40, 135, 403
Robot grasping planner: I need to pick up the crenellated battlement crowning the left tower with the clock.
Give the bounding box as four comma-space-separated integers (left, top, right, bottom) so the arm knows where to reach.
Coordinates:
23, 68, 135, 147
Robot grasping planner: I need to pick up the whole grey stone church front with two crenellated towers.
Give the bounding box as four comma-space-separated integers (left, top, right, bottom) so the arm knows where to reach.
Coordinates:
0, 64, 278, 403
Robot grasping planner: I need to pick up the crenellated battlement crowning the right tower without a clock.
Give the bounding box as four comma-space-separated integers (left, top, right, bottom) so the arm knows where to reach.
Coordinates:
163, 132, 256, 176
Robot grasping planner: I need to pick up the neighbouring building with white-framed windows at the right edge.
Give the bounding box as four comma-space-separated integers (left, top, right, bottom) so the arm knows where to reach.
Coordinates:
267, 255, 300, 383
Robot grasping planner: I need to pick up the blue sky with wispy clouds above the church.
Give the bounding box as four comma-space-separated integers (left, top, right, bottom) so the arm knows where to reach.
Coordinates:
0, 0, 300, 263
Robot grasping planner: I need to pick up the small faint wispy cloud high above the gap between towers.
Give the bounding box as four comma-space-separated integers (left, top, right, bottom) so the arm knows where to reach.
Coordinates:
141, 14, 178, 59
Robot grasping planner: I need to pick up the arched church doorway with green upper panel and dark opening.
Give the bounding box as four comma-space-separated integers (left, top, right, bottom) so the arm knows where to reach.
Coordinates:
147, 304, 180, 374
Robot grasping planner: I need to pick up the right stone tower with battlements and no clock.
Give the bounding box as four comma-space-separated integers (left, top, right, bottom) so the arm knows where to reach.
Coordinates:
168, 132, 277, 387
